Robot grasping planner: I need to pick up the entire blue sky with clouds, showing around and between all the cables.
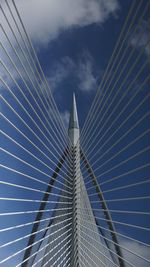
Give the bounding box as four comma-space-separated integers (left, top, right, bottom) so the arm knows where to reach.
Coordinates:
0, 0, 150, 267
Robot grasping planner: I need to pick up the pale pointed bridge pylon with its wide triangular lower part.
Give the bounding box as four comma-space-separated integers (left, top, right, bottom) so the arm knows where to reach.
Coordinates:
22, 94, 124, 267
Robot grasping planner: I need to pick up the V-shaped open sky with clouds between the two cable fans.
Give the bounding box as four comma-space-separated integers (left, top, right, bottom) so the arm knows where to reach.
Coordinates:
0, 0, 131, 126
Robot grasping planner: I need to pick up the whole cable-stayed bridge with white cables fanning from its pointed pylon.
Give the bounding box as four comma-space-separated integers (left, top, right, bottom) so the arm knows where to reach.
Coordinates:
0, 0, 150, 267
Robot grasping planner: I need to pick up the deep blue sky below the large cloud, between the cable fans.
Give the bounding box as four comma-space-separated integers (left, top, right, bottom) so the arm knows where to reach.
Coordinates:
29, 1, 130, 125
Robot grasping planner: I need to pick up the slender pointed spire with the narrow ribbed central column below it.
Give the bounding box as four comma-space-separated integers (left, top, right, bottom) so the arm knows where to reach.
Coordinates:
68, 94, 81, 266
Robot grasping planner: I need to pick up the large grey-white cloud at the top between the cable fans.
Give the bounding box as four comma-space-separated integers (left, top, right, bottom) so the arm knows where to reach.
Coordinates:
7, 0, 118, 44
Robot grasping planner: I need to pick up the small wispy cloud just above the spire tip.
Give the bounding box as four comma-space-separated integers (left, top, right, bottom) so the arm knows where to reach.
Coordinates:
48, 51, 97, 92
